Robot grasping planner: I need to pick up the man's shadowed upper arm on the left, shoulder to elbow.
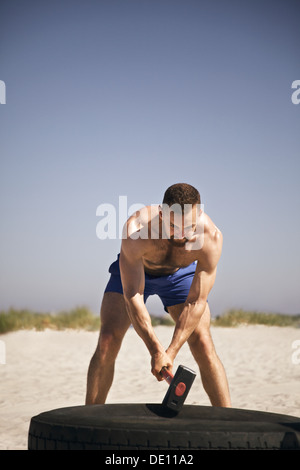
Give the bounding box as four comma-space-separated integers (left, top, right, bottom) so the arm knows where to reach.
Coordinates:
120, 240, 145, 298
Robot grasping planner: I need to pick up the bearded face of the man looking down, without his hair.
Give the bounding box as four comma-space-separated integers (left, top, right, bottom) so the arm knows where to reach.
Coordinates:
161, 205, 201, 247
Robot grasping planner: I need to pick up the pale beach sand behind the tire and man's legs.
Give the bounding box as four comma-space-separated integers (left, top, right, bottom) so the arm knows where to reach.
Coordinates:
0, 326, 300, 450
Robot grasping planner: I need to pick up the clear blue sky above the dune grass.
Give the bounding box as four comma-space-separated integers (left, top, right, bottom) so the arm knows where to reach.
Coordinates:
0, 0, 300, 314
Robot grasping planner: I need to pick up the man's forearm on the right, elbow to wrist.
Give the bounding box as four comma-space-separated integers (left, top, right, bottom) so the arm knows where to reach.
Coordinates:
167, 300, 206, 358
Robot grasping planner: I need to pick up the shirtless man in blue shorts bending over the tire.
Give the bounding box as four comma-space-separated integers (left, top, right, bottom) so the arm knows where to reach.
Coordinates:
86, 183, 231, 407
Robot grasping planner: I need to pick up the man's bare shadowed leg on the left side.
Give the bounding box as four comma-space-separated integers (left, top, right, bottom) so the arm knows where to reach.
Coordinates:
86, 292, 130, 405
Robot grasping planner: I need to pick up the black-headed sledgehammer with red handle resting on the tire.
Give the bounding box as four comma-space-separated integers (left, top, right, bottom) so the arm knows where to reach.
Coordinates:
161, 366, 196, 413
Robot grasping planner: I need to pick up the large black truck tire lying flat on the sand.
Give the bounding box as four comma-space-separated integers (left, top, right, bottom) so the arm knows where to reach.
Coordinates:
28, 404, 300, 450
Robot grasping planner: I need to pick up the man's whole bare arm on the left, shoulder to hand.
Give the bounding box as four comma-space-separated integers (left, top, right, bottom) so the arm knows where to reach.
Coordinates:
120, 238, 172, 380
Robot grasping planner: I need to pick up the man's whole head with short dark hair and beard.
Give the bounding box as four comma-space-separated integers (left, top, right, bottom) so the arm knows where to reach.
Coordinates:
160, 183, 201, 246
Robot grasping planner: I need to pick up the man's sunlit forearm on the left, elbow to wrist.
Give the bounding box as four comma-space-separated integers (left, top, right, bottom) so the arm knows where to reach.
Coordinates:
125, 294, 164, 356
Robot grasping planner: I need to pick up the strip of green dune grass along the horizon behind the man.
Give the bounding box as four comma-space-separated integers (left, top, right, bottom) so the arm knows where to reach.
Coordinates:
0, 307, 300, 334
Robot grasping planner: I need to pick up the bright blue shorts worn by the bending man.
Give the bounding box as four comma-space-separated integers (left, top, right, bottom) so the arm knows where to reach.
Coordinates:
105, 255, 197, 312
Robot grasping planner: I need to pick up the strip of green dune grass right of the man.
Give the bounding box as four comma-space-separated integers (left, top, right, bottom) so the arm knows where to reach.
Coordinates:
212, 309, 300, 328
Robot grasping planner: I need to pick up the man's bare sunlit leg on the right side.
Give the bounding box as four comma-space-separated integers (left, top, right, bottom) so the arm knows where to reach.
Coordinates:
168, 304, 231, 407
